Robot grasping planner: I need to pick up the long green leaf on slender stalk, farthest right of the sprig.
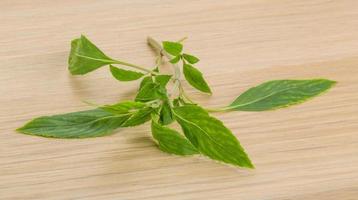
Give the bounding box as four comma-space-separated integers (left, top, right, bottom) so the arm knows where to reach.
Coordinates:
228, 79, 336, 111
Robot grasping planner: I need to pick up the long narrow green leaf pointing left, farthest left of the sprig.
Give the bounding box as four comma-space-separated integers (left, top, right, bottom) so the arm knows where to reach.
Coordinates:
17, 109, 130, 138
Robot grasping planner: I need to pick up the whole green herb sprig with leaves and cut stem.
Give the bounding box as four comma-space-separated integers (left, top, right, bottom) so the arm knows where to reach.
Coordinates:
18, 35, 335, 168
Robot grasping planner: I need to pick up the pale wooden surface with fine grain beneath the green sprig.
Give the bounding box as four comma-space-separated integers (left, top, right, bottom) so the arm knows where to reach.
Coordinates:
0, 0, 358, 200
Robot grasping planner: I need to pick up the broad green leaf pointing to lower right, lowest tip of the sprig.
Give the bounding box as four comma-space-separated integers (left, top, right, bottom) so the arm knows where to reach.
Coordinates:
173, 105, 254, 168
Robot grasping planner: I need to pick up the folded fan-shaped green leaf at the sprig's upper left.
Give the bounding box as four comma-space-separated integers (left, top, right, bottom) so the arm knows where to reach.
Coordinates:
68, 35, 116, 75
